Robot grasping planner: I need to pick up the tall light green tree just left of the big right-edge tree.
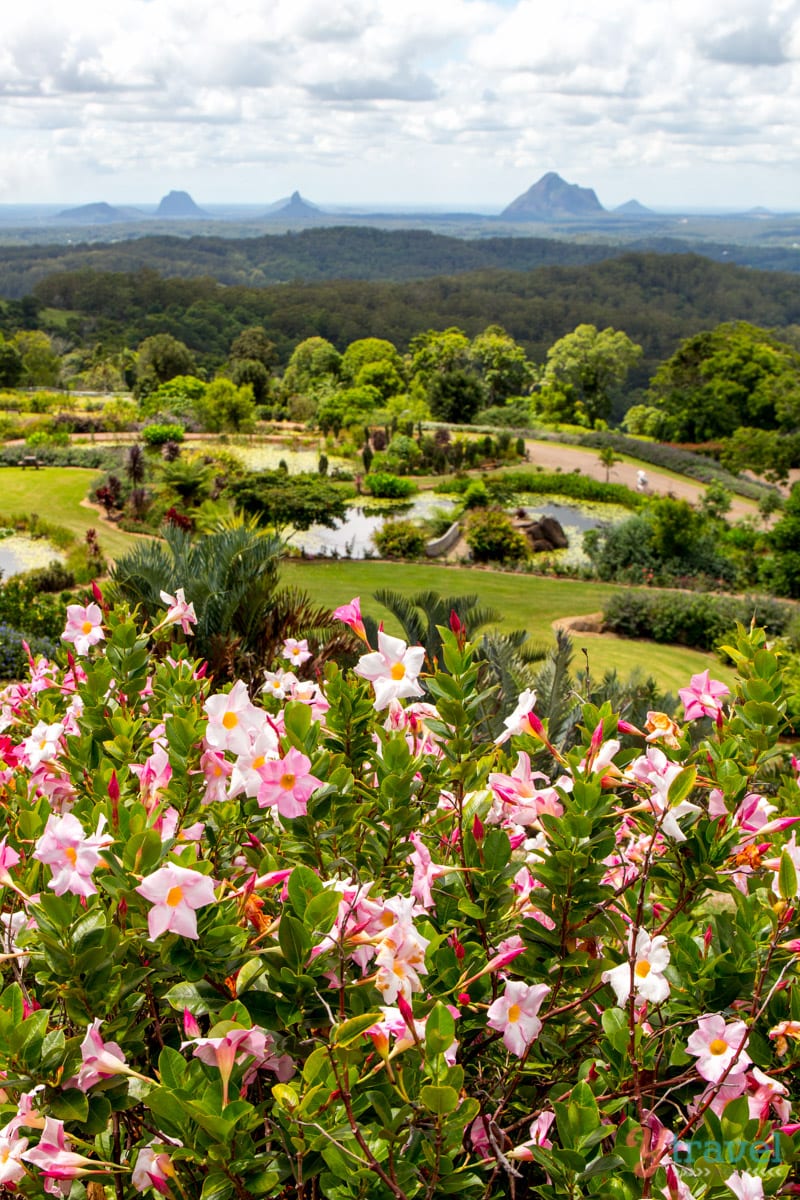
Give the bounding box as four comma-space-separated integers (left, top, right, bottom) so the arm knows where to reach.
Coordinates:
543, 325, 642, 426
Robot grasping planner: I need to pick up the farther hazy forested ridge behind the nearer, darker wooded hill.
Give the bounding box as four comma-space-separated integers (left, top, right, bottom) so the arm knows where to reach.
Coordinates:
0, 227, 800, 299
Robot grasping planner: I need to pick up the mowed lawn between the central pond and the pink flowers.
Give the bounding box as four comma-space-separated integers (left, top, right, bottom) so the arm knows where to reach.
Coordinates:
282, 559, 733, 691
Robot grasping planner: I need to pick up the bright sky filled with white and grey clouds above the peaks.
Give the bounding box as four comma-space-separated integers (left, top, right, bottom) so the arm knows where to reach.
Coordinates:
0, 0, 800, 211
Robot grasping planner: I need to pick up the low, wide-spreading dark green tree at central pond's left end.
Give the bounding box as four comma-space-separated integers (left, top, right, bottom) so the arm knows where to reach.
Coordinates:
225, 470, 347, 535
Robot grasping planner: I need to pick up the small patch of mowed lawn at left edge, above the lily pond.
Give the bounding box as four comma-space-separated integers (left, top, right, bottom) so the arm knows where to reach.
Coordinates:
0, 467, 137, 558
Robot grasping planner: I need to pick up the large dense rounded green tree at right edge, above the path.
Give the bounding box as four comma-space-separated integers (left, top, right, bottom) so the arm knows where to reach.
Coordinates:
648, 322, 800, 442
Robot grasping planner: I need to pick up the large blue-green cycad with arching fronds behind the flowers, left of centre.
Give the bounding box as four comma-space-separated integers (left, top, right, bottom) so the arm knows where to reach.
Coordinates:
109, 517, 353, 686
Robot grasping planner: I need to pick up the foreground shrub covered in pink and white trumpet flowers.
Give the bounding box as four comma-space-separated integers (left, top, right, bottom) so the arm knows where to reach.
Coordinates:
0, 595, 800, 1200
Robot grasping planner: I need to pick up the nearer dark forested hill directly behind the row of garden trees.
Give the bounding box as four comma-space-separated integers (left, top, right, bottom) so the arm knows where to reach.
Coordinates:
35, 253, 800, 380
